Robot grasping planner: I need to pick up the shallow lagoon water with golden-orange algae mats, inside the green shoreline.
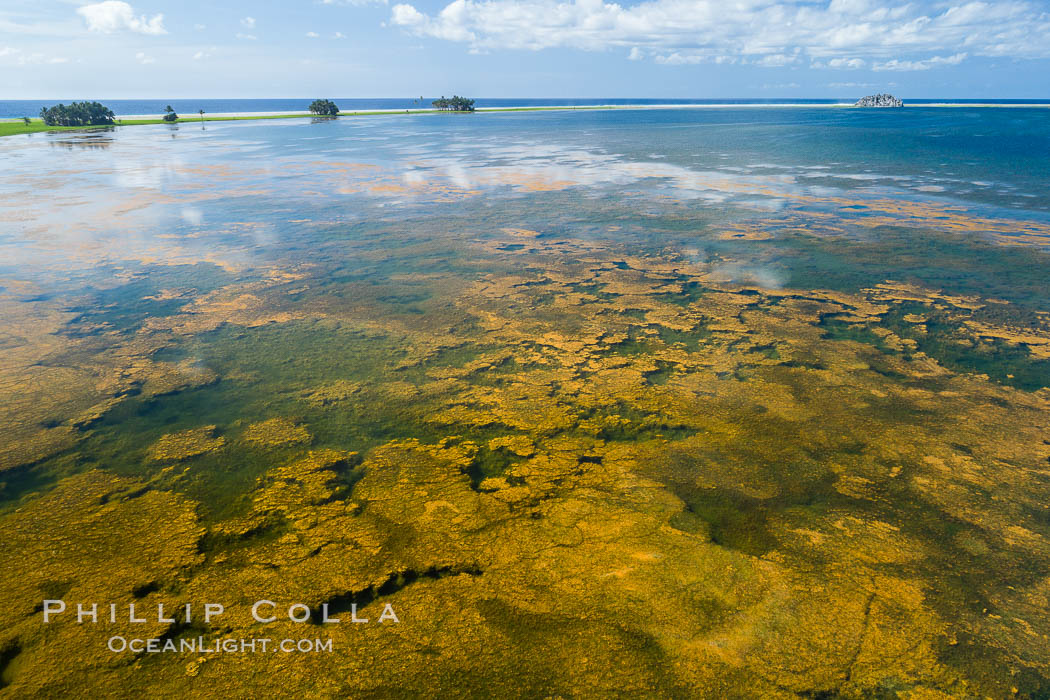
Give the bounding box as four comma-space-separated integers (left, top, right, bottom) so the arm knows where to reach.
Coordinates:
0, 107, 1050, 697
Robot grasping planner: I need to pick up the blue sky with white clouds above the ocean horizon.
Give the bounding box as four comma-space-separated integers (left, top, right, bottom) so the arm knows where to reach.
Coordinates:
0, 0, 1050, 100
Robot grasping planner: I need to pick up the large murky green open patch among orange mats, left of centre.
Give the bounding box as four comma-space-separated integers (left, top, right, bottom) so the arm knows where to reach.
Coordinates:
58, 322, 503, 518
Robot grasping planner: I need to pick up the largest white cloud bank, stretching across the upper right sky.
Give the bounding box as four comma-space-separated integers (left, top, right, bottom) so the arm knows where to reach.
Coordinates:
391, 0, 1050, 63
